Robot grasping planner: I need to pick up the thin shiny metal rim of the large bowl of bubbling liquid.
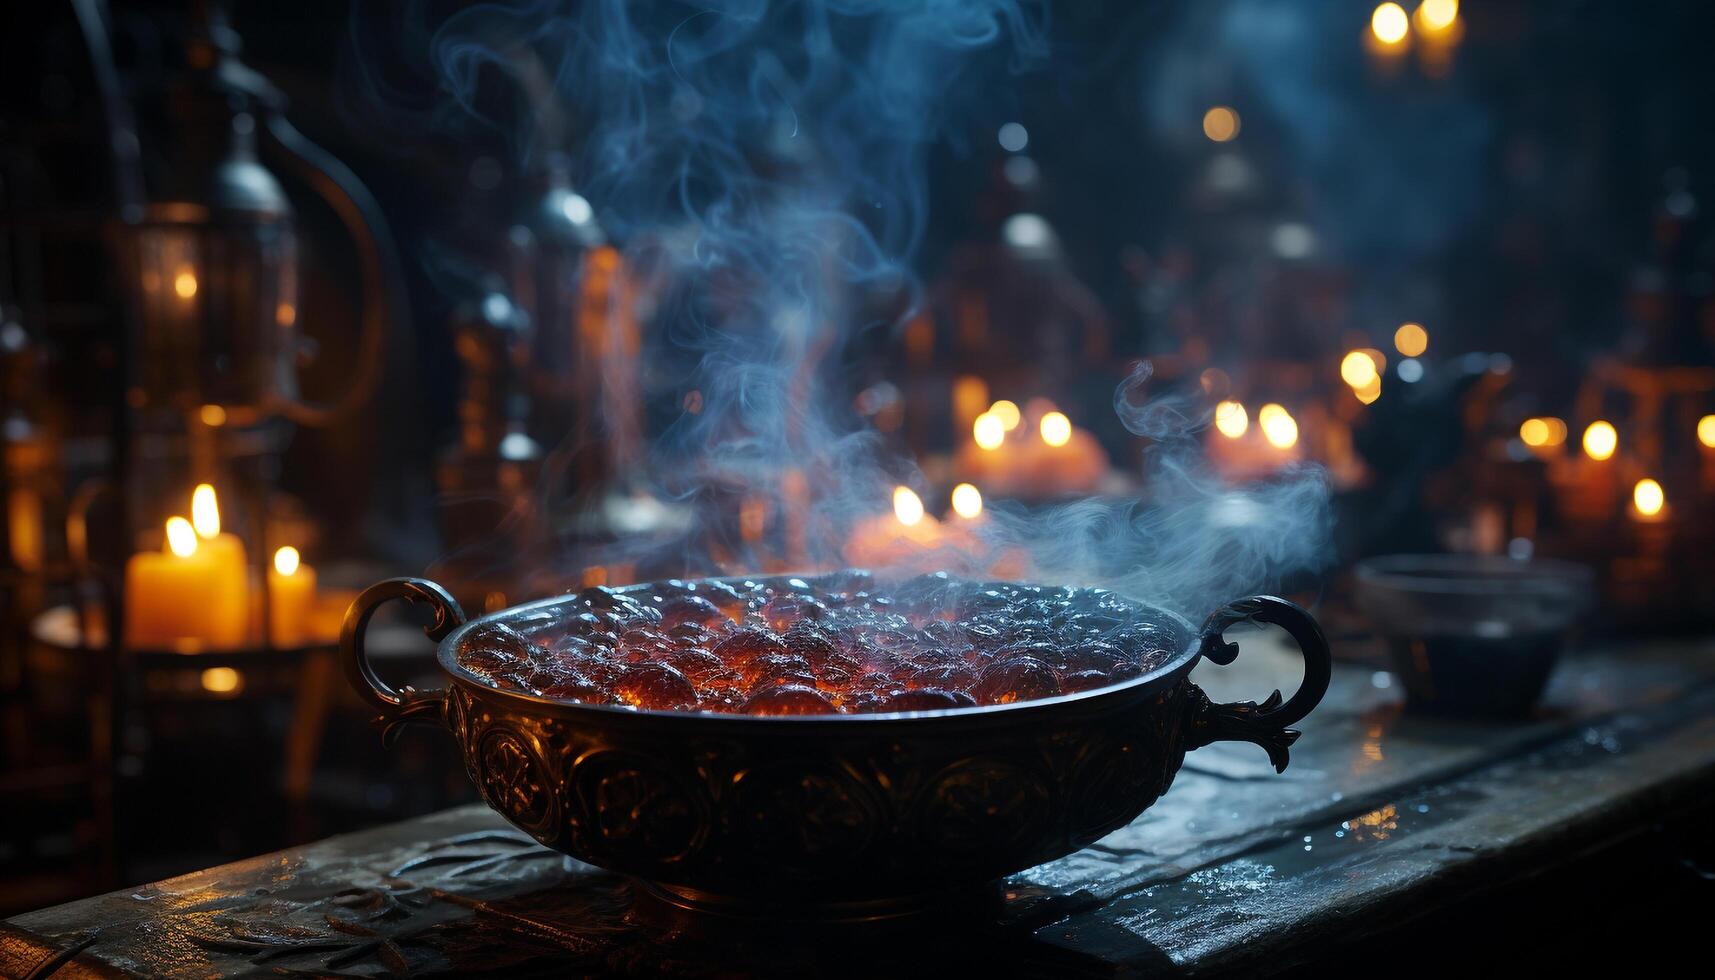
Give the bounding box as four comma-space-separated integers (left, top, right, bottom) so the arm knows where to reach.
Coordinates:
436, 573, 1201, 726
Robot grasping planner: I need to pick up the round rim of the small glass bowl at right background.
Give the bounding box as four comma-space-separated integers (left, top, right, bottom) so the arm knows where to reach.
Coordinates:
1353, 554, 1595, 597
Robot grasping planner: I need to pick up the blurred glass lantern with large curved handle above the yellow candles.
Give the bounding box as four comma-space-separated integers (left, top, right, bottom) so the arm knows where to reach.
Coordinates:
129, 5, 400, 427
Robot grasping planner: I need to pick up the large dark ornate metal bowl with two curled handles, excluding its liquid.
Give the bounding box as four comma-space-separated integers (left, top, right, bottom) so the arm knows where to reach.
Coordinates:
340, 578, 1331, 918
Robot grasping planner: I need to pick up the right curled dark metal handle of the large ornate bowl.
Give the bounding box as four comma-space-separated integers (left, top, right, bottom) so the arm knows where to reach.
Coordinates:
1188, 596, 1334, 772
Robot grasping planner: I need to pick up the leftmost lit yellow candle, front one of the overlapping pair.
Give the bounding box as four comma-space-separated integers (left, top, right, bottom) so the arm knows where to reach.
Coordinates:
125, 517, 220, 650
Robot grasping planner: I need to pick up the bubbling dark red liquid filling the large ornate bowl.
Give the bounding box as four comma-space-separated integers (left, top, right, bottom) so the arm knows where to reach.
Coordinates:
458, 572, 1183, 716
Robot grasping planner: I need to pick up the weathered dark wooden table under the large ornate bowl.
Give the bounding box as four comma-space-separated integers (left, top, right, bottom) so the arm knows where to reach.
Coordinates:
0, 640, 1715, 977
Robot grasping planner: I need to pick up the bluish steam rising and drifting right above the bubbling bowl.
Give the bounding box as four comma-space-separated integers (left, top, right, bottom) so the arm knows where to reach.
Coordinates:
358, 0, 1329, 611
